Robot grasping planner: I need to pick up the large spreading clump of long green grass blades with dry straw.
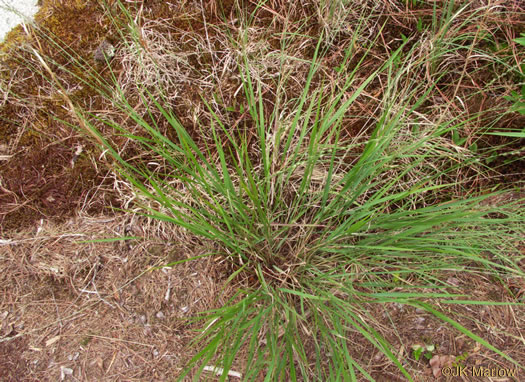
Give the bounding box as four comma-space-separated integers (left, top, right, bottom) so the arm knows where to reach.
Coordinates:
10, 2, 524, 381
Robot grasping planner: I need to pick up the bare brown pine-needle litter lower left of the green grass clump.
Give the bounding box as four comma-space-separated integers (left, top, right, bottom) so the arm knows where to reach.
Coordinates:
0, 215, 236, 381
